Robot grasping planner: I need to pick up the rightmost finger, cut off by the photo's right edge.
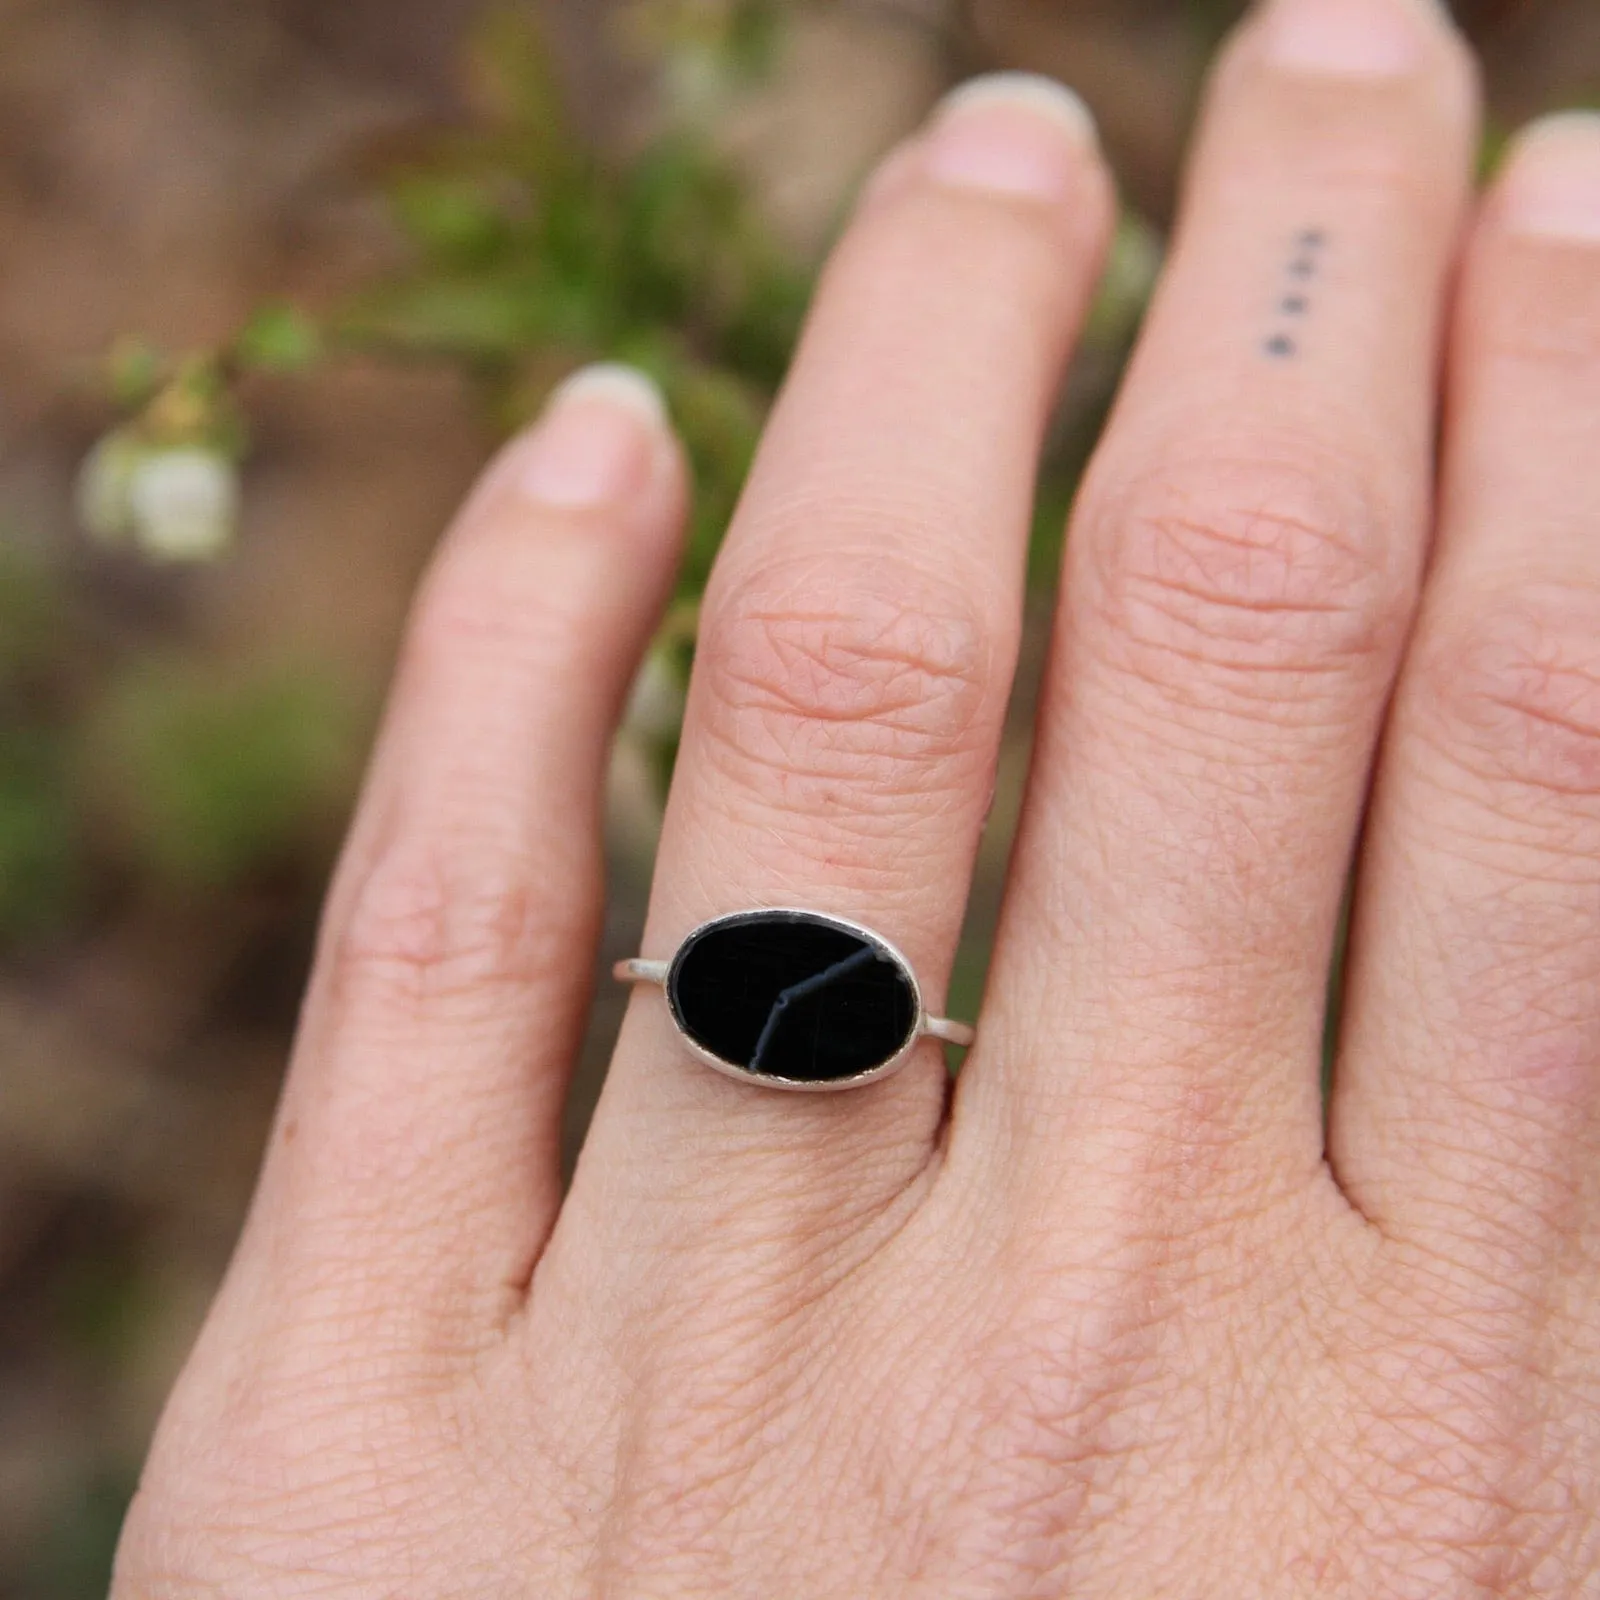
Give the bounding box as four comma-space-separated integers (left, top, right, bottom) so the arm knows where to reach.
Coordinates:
1330, 117, 1600, 1283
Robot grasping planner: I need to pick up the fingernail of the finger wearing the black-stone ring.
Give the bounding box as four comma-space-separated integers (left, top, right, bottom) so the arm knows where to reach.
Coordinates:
923, 72, 1096, 200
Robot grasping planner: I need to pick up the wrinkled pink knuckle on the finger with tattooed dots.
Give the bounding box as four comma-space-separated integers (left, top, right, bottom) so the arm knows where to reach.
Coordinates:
1083, 462, 1414, 688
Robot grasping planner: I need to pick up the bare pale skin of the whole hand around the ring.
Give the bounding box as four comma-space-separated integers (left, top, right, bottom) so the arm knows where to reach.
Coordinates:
115, 0, 1600, 1600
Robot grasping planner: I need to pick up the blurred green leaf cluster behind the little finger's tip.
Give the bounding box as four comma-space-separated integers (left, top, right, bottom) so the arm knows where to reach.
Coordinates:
339, 3, 811, 595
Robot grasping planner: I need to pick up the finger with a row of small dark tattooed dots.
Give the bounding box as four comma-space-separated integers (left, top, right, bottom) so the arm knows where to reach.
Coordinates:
955, 0, 1474, 1197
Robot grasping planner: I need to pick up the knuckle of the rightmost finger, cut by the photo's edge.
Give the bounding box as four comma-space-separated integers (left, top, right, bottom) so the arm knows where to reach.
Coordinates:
1418, 587, 1600, 810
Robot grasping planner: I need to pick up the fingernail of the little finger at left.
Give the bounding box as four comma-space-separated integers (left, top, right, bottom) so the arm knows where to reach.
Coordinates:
518, 362, 667, 510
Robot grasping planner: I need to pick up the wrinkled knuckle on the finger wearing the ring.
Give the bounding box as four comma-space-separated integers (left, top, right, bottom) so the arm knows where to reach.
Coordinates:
698, 563, 994, 805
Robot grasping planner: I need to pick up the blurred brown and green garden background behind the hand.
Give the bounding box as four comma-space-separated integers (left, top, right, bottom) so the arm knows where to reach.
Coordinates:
0, 0, 1600, 1600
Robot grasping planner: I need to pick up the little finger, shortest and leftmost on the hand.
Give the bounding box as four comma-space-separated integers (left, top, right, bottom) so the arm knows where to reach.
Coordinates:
238, 366, 685, 1307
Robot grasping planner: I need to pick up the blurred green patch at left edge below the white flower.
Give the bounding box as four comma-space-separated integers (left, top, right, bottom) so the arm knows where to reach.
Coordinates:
0, 530, 362, 949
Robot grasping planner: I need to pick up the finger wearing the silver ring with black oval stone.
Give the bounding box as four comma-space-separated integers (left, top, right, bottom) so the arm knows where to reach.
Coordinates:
576, 78, 1110, 1227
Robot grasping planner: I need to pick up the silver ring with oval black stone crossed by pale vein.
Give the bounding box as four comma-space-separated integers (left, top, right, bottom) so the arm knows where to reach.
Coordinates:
613, 907, 973, 1091
